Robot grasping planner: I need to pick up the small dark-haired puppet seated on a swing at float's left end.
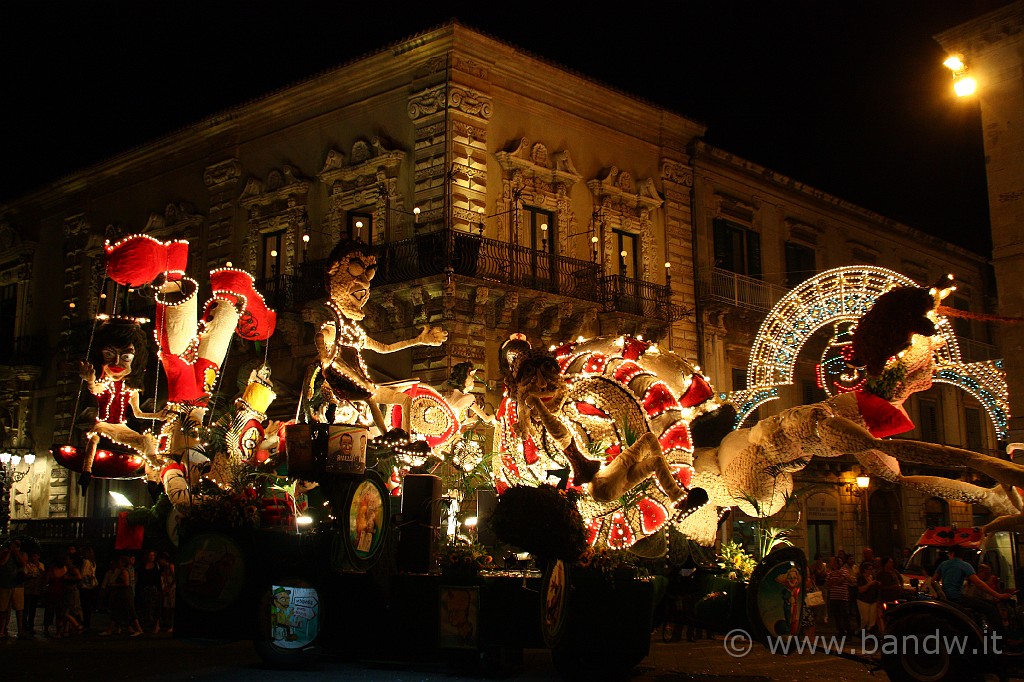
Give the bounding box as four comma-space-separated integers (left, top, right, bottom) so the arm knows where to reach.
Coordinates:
78, 318, 164, 489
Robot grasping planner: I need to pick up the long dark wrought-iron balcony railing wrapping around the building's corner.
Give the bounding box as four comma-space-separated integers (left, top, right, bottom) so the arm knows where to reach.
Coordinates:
257, 229, 680, 319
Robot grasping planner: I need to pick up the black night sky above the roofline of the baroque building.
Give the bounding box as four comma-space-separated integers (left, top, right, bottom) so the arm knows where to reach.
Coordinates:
0, 0, 1007, 255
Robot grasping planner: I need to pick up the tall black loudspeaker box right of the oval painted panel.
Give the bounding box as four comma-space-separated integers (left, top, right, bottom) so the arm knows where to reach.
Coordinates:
395, 474, 441, 573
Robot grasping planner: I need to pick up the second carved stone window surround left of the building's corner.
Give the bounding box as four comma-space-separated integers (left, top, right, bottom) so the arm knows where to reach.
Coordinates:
240, 166, 312, 274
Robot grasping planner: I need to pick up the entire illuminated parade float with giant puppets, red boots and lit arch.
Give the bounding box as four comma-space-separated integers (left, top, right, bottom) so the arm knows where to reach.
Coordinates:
53, 236, 1024, 676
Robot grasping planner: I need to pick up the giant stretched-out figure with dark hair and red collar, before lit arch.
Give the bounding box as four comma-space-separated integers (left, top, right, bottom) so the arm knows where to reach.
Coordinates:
680, 274, 1024, 545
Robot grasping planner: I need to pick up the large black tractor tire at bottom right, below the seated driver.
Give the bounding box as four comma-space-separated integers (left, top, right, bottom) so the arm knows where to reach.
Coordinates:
882, 614, 984, 682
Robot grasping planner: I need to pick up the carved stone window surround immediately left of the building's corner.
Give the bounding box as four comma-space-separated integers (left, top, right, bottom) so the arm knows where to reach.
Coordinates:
317, 137, 408, 243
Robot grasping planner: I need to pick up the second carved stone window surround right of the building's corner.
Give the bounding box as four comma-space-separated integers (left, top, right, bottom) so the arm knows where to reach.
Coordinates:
587, 166, 665, 282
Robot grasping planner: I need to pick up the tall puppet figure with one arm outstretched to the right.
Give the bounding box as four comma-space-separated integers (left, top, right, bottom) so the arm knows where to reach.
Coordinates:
315, 240, 447, 434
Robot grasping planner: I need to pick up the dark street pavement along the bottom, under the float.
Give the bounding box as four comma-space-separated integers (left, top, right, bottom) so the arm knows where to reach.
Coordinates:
0, 613, 888, 682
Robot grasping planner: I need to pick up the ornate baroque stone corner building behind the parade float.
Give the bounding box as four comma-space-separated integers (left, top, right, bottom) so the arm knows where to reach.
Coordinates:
0, 22, 996, 561
